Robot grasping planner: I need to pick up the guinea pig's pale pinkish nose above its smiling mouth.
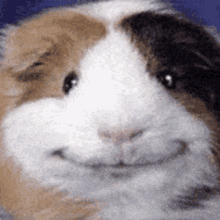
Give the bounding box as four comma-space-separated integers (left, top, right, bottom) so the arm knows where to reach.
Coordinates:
99, 129, 145, 145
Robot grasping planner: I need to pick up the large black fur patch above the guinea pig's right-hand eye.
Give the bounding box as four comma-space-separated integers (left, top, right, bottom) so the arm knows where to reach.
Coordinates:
120, 12, 220, 111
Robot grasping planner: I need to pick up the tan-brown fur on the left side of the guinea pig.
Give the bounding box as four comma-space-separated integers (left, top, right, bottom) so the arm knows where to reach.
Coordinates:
0, 10, 106, 220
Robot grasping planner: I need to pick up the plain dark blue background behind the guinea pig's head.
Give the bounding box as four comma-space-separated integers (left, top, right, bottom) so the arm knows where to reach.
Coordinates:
0, 0, 220, 32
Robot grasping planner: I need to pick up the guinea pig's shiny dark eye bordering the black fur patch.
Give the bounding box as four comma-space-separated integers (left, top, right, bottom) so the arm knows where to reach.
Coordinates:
157, 70, 176, 89
